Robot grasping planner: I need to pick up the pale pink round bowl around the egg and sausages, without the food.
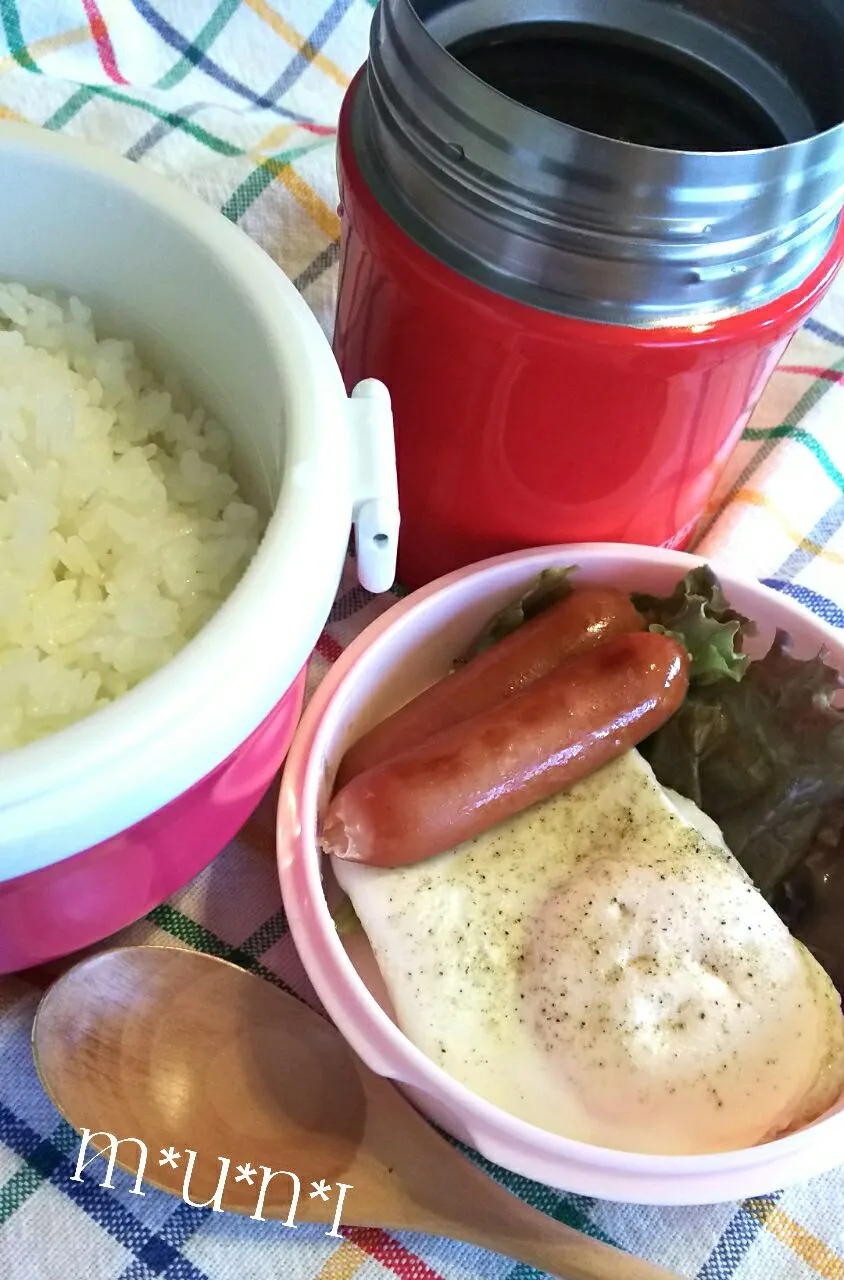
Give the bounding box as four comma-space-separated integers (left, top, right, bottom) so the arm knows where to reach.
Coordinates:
278, 544, 844, 1204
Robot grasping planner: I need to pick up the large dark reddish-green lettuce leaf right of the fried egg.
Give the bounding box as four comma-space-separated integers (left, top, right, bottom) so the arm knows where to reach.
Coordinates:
640, 631, 844, 901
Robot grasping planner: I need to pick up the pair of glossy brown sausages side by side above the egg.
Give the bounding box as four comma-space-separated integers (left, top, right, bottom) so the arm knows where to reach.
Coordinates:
320, 588, 689, 867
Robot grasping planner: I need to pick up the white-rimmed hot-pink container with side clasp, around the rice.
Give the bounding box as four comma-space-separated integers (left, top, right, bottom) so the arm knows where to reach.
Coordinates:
0, 123, 398, 973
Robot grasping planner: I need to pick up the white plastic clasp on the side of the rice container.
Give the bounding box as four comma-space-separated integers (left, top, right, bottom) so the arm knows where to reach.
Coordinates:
348, 378, 398, 593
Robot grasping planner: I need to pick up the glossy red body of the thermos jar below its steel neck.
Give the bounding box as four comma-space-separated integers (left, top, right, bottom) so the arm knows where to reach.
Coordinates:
334, 4, 844, 588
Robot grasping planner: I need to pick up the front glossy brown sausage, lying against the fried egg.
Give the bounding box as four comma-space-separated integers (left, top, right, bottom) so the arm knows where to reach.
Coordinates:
320, 632, 689, 867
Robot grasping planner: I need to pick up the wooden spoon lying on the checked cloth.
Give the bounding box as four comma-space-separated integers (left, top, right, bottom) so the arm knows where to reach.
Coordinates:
32, 947, 678, 1280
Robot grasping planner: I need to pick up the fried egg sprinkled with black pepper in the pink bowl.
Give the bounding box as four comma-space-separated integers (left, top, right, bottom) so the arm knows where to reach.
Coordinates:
333, 751, 844, 1155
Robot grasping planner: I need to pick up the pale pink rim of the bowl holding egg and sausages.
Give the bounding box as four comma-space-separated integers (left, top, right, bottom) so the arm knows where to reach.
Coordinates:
277, 543, 844, 1204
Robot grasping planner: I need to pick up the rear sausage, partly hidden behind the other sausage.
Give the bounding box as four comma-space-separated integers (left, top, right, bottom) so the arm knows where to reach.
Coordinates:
337, 586, 644, 787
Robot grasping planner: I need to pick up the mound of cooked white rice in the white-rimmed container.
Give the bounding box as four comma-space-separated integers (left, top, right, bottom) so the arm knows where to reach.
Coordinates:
0, 275, 261, 750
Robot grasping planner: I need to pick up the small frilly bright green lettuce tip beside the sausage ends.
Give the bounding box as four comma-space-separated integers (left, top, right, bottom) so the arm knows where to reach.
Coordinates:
631, 564, 754, 685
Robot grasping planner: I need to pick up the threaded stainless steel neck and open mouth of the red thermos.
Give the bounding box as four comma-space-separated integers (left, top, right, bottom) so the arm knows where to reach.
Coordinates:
352, 0, 844, 326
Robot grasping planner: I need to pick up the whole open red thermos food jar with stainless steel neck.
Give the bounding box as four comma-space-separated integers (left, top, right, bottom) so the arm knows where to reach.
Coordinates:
334, 0, 844, 588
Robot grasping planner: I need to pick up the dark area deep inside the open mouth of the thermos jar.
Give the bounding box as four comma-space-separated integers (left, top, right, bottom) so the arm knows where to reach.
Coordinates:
450, 23, 789, 151
